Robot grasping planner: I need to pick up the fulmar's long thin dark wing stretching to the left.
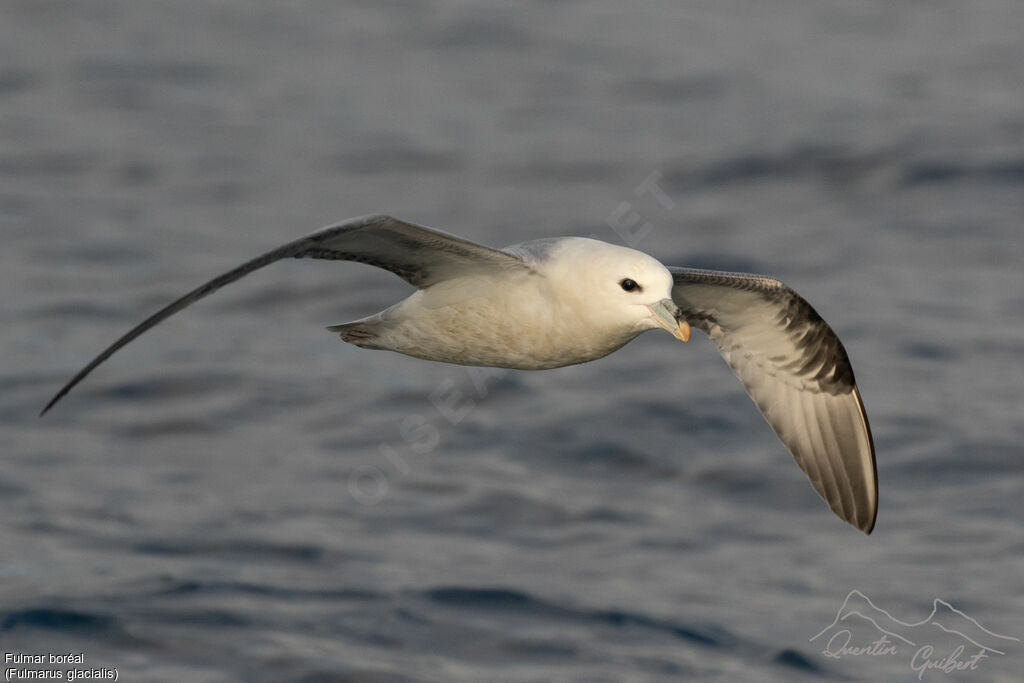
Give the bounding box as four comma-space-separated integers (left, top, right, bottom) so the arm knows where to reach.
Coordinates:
40, 215, 528, 415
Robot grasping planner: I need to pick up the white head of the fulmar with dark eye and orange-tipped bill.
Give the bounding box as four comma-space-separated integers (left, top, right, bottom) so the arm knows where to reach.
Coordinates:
546, 238, 690, 341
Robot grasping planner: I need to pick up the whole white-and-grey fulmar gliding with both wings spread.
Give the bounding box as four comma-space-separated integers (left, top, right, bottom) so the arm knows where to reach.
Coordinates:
43, 216, 878, 532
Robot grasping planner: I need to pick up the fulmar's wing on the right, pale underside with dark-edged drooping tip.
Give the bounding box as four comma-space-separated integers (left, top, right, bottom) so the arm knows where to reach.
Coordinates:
669, 268, 878, 533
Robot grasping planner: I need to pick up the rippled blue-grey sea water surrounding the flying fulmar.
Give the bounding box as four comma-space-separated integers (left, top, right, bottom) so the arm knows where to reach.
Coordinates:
0, 0, 1024, 683
